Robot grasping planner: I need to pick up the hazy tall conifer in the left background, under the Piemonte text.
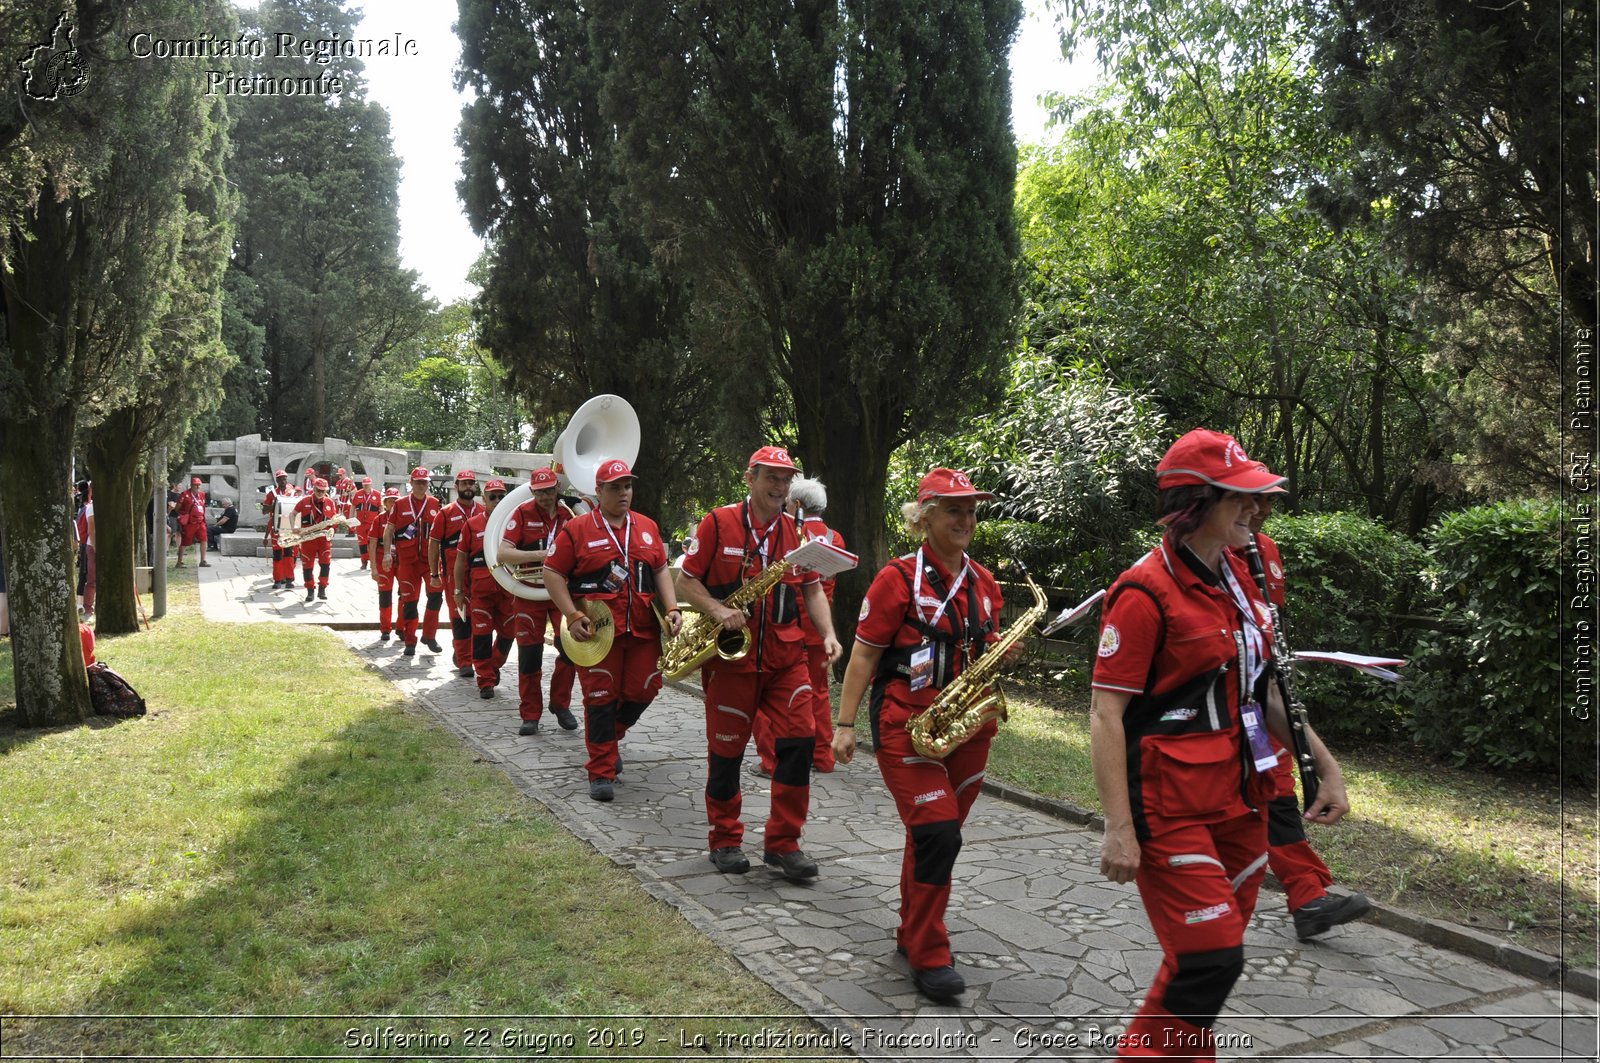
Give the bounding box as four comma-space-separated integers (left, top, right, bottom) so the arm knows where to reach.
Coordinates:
230, 0, 429, 440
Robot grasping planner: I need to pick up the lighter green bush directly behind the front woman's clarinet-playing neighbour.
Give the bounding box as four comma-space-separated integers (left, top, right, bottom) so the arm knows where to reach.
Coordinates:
1266, 512, 1427, 738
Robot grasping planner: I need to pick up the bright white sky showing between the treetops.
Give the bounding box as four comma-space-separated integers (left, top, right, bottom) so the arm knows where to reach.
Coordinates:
357, 0, 1093, 303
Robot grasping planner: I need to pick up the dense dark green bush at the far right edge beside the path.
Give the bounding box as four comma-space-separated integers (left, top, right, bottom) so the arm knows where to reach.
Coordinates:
1408, 501, 1594, 784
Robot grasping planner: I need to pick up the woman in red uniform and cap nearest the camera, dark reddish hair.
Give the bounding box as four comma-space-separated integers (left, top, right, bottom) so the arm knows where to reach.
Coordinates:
1090, 429, 1349, 1060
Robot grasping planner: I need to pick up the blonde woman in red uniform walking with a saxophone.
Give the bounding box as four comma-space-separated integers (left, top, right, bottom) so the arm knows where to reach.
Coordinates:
834, 469, 1000, 1001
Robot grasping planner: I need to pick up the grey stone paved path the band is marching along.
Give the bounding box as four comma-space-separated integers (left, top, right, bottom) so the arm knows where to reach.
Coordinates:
202, 557, 1597, 1063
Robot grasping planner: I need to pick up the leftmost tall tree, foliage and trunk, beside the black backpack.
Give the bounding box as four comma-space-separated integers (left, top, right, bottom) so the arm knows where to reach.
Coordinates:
0, 0, 228, 725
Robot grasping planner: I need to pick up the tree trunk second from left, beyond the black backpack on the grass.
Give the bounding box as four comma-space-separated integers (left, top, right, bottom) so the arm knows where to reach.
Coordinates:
83, 410, 144, 636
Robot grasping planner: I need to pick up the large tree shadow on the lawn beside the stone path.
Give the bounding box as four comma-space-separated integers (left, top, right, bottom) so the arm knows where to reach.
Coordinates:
6, 703, 790, 1058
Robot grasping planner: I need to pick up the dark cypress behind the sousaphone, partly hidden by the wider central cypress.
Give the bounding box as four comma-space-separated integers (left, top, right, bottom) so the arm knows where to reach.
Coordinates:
458, 0, 748, 525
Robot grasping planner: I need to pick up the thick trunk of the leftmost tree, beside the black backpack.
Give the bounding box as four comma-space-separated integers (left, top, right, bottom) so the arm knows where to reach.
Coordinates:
0, 407, 94, 727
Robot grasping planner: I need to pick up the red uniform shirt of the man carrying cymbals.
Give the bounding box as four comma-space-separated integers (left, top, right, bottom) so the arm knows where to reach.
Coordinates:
544, 509, 667, 636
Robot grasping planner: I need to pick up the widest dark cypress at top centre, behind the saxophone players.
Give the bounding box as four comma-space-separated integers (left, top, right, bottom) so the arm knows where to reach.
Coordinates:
594, 0, 1021, 634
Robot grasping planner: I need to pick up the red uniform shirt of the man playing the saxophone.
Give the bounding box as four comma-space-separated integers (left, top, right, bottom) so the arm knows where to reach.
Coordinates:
683, 501, 821, 671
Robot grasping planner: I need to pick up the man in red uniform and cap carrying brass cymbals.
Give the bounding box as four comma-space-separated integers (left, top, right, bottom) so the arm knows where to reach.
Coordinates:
544, 458, 683, 800
